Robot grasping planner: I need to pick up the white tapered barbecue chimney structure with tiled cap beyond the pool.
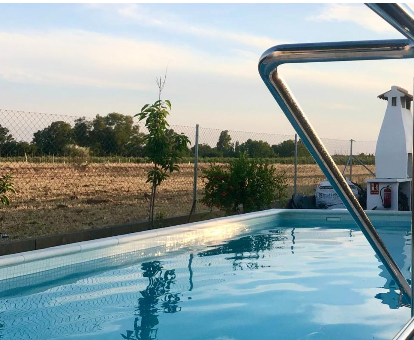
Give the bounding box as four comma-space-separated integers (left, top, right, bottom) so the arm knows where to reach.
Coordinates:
367, 86, 413, 210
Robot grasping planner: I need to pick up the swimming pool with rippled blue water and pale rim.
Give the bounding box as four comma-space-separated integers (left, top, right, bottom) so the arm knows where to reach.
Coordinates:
0, 210, 411, 340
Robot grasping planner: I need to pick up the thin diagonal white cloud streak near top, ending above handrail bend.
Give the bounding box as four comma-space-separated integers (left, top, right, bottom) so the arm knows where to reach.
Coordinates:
85, 4, 282, 49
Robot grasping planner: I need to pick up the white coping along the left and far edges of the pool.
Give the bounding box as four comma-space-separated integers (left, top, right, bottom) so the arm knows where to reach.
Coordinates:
0, 209, 411, 281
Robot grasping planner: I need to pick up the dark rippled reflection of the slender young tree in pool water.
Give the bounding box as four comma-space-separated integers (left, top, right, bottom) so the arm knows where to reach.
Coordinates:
121, 258, 183, 340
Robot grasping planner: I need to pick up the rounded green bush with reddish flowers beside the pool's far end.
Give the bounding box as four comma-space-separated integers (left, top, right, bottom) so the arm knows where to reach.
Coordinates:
201, 154, 287, 214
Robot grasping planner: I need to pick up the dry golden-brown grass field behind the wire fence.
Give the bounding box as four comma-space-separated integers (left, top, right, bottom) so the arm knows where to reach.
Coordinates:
0, 163, 374, 239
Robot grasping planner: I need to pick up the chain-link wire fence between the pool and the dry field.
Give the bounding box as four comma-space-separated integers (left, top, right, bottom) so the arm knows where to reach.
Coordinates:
0, 109, 376, 238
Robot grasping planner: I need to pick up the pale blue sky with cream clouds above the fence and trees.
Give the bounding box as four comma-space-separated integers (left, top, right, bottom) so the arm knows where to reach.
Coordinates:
0, 3, 414, 141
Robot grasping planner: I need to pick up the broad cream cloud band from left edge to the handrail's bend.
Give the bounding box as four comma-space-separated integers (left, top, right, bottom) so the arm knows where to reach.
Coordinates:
0, 30, 258, 90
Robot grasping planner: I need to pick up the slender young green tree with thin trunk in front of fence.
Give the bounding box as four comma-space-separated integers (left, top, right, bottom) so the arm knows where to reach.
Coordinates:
137, 100, 190, 227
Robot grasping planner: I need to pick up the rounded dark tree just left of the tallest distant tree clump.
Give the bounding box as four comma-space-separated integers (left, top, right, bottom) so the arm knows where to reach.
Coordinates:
33, 121, 73, 155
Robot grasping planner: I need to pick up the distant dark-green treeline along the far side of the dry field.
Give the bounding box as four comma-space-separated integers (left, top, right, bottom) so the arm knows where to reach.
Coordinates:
0, 112, 374, 164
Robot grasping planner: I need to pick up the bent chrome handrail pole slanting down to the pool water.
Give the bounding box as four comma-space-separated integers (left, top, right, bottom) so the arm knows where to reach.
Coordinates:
258, 40, 414, 299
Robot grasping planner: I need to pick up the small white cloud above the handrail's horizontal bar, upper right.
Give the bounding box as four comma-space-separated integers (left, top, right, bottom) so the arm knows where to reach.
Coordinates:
307, 3, 396, 33
